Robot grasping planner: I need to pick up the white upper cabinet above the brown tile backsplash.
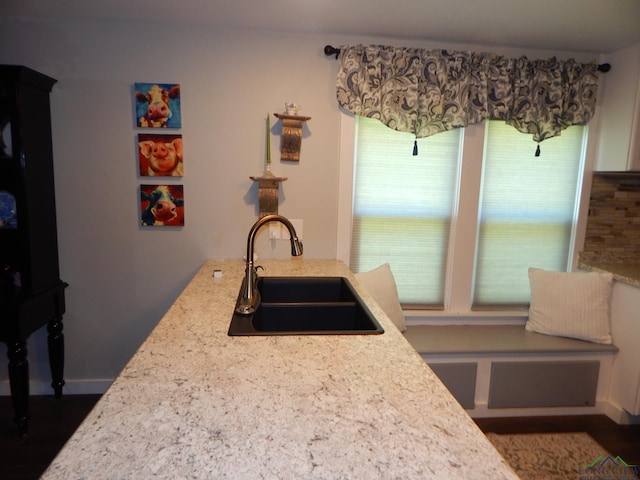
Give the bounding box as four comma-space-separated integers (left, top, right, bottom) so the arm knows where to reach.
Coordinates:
595, 44, 640, 172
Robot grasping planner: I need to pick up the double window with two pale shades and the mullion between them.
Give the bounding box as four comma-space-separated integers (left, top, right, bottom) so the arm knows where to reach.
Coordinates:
350, 117, 586, 310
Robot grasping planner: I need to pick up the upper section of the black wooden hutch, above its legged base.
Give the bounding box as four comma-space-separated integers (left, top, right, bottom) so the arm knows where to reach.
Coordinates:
0, 65, 60, 295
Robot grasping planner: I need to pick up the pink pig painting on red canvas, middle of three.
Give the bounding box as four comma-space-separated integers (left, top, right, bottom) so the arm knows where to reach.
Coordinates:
138, 133, 184, 177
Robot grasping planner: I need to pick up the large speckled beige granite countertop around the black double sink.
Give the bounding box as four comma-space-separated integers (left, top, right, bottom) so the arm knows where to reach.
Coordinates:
42, 258, 517, 480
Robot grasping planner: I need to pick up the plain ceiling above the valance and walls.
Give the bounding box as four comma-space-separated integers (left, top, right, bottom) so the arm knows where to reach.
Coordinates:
0, 0, 640, 53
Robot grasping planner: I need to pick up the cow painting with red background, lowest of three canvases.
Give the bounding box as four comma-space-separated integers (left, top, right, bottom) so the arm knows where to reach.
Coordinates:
140, 185, 184, 227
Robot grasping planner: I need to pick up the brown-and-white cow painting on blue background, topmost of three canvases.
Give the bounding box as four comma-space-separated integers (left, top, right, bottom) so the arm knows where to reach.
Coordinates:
134, 83, 182, 128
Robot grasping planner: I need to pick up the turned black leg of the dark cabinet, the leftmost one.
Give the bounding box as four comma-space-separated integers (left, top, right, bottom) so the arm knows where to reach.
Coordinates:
7, 340, 29, 435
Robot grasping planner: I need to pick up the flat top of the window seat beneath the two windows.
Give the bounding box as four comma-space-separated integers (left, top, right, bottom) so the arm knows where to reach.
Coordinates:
405, 325, 618, 354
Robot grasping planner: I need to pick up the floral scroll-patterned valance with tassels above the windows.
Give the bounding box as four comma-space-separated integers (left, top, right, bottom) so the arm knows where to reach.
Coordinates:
337, 45, 598, 150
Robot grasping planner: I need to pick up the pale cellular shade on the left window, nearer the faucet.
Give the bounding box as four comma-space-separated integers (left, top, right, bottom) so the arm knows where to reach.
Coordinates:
351, 117, 463, 306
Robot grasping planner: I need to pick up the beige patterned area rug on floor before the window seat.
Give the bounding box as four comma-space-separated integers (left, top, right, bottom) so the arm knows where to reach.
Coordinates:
487, 432, 638, 480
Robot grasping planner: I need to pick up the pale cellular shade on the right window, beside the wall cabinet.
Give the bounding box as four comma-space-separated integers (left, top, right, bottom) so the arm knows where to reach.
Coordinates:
473, 121, 585, 308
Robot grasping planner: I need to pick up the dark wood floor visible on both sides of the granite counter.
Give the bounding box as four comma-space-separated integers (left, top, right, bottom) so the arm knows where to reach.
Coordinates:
0, 395, 640, 480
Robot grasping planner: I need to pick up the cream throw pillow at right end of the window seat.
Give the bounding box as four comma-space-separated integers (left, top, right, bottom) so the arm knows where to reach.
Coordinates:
525, 268, 613, 343
